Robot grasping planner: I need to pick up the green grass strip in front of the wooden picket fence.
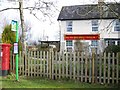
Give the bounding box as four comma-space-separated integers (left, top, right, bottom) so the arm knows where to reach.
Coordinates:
1, 75, 119, 89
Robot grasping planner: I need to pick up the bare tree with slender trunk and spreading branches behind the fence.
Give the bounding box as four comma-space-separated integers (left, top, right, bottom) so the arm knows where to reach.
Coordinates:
0, 0, 57, 52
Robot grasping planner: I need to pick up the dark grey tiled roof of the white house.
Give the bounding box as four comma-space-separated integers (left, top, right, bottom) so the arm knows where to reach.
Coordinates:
58, 3, 120, 21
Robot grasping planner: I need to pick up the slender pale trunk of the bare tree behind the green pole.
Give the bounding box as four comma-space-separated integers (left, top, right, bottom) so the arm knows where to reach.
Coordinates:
19, 0, 26, 54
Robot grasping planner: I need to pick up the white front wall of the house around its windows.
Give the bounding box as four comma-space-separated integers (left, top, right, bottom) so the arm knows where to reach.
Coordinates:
59, 19, 119, 50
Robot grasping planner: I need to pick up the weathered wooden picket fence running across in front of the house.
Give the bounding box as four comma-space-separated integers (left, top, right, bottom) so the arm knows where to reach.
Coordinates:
11, 51, 120, 84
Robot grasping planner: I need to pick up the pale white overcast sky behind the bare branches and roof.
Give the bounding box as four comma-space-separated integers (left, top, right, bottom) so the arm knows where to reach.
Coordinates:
0, 0, 120, 41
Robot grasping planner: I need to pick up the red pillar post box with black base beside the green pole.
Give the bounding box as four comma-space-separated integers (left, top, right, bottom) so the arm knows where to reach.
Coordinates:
0, 44, 11, 76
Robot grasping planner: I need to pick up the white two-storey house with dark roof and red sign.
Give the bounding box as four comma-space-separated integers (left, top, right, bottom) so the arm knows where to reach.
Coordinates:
58, 2, 120, 52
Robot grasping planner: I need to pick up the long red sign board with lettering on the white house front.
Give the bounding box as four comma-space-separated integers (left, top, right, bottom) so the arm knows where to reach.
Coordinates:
64, 34, 100, 40
